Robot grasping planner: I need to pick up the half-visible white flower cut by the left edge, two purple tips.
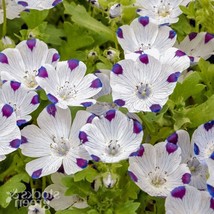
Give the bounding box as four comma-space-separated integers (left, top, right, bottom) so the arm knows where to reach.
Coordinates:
0, 104, 21, 160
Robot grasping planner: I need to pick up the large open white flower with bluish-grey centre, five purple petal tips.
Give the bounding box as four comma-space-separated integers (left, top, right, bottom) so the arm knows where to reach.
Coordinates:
110, 52, 188, 112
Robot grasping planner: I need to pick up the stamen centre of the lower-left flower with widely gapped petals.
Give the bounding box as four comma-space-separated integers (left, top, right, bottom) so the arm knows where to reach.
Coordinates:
50, 136, 70, 157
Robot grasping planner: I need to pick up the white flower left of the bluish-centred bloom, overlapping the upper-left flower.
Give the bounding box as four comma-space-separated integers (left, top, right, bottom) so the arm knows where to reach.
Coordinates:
36, 59, 102, 108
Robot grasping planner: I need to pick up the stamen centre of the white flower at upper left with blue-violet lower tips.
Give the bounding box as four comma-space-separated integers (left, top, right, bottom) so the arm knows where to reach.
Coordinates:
57, 81, 77, 100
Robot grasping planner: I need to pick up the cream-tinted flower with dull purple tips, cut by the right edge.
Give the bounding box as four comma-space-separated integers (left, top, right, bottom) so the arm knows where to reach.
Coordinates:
176, 32, 214, 63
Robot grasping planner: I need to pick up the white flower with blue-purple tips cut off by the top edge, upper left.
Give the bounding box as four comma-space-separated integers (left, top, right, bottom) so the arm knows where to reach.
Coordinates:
15, 0, 63, 10
